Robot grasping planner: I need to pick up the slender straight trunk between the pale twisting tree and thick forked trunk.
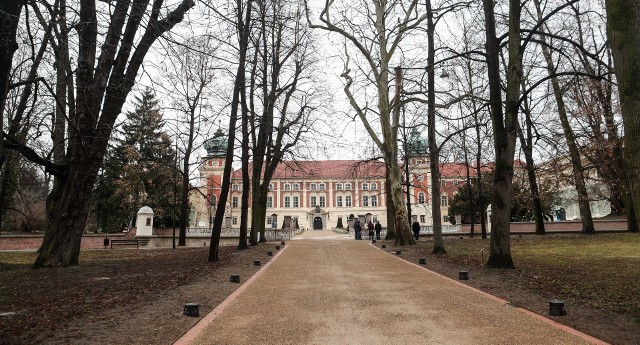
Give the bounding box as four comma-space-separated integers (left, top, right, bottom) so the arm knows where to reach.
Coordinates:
426, 0, 447, 254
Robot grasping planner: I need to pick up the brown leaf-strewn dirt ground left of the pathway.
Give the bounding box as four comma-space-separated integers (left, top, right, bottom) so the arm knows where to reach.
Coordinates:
0, 243, 275, 344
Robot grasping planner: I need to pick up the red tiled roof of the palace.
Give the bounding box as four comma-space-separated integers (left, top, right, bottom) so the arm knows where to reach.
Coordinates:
233, 160, 386, 180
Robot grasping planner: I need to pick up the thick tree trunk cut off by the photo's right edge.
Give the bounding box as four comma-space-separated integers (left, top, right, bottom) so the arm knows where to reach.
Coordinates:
605, 0, 640, 232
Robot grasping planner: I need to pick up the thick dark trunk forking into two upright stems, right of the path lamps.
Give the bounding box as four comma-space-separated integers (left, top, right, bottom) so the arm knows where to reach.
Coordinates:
483, 0, 521, 268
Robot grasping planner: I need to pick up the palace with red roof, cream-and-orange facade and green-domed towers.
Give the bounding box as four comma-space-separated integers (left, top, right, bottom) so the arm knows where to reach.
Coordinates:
190, 129, 457, 230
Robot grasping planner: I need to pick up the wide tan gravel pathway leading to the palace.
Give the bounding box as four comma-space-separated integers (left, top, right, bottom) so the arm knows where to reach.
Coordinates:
177, 233, 604, 344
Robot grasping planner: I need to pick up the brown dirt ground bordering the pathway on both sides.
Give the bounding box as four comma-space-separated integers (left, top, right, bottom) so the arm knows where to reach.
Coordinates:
0, 236, 640, 344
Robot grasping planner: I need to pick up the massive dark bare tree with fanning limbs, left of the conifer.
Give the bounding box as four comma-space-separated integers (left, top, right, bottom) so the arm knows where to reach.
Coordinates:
0, 0, 194, 267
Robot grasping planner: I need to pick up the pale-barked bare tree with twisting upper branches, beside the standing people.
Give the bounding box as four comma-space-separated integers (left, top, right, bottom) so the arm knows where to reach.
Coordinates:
307, 0, 427, 245
